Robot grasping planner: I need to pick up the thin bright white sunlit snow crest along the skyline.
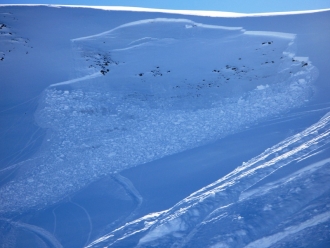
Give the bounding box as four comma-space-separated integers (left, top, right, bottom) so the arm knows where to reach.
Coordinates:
0, 4, 330, 17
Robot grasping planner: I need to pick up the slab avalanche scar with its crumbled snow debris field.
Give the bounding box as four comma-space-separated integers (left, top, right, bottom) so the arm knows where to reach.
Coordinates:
0, 19, 315, 215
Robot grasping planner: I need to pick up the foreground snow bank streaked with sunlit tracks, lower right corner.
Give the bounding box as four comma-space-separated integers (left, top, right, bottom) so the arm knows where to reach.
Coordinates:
90, 112, 330, 247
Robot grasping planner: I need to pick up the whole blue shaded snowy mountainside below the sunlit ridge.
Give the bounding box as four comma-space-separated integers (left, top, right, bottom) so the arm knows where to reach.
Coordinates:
0, 6, 330, 247
